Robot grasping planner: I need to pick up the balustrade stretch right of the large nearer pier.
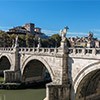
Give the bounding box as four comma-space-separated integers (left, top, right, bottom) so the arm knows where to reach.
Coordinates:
68, 48, 100, 55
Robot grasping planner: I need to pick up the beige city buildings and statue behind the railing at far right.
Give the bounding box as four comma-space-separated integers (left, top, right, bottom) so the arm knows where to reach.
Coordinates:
68, 32, 100, 48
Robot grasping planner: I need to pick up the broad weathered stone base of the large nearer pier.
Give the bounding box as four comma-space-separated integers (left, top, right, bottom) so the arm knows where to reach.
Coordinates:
44, 83, 70, 100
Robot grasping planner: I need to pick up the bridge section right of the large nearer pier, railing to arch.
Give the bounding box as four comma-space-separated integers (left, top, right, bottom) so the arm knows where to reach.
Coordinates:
68, 48, 100, 100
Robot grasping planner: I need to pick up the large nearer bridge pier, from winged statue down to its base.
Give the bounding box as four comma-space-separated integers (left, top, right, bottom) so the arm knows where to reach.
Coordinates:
44, 27, 71, 100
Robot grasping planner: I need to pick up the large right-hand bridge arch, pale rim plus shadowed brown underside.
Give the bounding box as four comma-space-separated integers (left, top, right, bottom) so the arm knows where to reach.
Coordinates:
74, 62, 100, 100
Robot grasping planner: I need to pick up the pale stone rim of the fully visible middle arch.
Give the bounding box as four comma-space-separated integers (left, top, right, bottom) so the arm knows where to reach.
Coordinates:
21, 56, 54, 80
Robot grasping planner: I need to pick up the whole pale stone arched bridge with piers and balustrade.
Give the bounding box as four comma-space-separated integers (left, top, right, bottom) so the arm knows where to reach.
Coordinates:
0, 27, 100, 100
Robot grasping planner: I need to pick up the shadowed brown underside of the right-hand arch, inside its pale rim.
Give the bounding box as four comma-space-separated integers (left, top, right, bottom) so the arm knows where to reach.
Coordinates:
75, 69, 100, 100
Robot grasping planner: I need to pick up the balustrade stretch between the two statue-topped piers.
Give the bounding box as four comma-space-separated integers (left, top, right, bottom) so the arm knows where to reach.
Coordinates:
19, 47, 58, 53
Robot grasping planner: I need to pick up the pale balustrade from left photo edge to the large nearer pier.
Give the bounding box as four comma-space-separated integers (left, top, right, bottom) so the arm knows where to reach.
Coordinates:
0, 47, 64, 55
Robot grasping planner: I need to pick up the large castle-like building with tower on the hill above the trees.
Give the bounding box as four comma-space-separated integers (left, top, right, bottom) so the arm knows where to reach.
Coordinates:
7, 23, 47, 38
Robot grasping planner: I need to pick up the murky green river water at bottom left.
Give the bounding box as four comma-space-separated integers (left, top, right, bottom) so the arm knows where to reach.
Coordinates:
0, 89, 46, 100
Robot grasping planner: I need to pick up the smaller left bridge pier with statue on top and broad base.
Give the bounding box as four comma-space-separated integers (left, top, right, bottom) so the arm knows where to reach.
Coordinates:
4, 37, 21, 83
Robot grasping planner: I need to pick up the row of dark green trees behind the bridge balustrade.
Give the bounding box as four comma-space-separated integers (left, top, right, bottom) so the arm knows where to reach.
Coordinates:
0, 31, 70, 47
